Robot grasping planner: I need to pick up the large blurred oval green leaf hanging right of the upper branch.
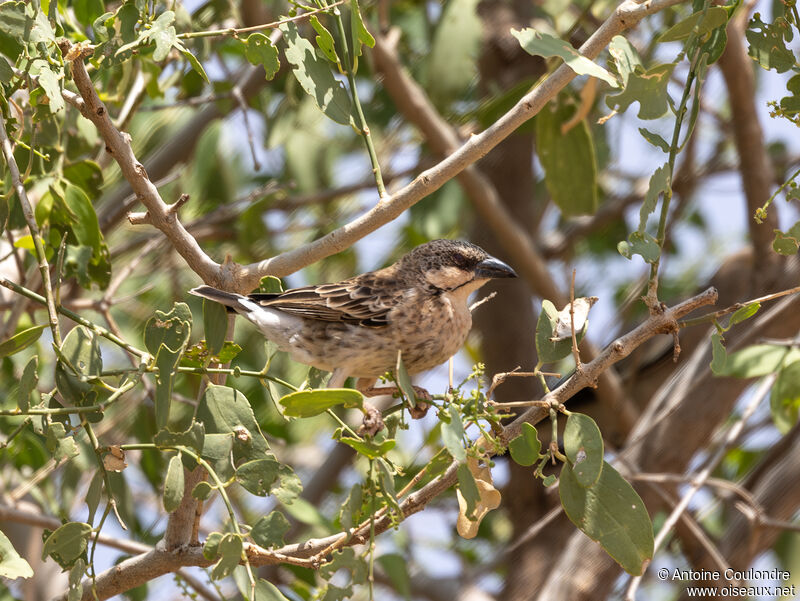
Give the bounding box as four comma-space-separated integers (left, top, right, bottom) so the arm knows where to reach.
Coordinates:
536, 102, 598, 217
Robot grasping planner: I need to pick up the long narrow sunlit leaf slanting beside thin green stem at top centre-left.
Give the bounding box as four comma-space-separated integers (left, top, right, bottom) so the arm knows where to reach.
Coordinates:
280, 23, 353, 125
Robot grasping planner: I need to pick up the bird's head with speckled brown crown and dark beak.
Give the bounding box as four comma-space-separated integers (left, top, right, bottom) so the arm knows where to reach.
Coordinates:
400, 240, 517, 293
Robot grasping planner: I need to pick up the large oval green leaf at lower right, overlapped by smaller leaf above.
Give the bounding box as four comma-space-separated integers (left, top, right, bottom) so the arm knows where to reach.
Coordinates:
558, 463, 653, 576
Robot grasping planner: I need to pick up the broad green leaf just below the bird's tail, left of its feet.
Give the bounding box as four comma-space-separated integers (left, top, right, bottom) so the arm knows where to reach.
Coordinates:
197, 384, 269, 463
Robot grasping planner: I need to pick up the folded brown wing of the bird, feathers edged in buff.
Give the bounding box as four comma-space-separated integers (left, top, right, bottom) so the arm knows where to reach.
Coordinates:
248, 274, 401, 327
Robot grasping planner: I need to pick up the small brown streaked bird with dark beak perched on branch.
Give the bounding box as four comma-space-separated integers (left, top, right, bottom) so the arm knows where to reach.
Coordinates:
190, 240, 517, 391
